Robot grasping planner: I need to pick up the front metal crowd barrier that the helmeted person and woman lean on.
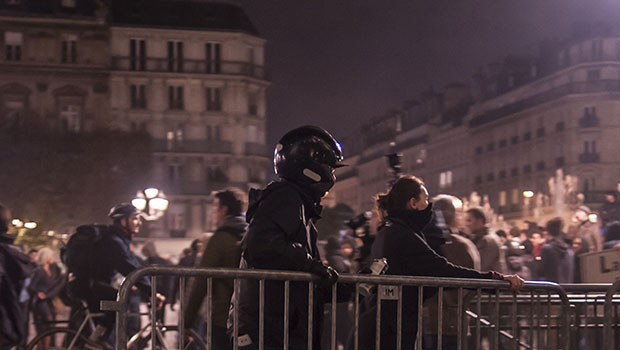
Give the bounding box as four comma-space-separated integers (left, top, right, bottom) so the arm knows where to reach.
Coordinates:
101, 266, 572, 350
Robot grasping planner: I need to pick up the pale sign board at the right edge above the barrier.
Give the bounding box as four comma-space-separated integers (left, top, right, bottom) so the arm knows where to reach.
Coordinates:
579, 248, 620, 283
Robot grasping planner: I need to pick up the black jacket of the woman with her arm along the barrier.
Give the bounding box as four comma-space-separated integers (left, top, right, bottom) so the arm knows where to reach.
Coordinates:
359, 206, 494, 349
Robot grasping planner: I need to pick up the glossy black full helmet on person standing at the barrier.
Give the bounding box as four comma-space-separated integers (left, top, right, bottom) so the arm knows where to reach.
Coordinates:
273, 126, 345, 197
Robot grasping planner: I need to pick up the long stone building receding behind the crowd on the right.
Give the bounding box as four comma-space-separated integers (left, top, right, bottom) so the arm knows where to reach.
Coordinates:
332, 28, 620, 224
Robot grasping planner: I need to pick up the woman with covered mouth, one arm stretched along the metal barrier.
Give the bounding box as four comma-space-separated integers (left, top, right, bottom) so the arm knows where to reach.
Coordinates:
350, 176, 524, 350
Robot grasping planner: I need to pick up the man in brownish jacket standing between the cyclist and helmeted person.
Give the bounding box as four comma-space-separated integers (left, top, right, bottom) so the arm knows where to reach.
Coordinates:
184, 189, 247, 350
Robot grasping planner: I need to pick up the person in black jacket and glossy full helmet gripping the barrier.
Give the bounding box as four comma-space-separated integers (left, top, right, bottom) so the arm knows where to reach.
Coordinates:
228, 126, 342, 350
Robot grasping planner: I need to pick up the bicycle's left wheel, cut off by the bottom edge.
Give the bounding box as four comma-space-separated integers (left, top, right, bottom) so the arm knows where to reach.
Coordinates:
26, 328, 94, 350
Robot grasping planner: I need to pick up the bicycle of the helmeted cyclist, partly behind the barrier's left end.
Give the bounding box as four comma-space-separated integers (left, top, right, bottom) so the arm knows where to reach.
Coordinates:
26, 304, 207, 350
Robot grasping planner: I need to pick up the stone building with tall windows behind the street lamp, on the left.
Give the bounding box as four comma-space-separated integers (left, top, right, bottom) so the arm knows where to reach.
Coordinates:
0, 0, 270, 237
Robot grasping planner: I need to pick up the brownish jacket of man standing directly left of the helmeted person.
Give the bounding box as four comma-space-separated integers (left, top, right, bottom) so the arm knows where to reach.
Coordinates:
185, 216, 247, 328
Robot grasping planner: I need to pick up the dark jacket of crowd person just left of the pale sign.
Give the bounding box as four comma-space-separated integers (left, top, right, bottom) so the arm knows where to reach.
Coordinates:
538, 238, 575, 283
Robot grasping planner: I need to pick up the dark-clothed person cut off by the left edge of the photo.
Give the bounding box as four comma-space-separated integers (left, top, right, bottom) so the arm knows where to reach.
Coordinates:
0, 204, 35, 350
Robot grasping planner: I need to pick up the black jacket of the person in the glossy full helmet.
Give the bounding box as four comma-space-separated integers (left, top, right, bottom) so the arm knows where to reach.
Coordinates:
228, 180, 323, 350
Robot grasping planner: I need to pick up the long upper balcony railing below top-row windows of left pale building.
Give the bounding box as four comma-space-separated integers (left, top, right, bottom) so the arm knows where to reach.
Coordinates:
112, 56, 267, 79
